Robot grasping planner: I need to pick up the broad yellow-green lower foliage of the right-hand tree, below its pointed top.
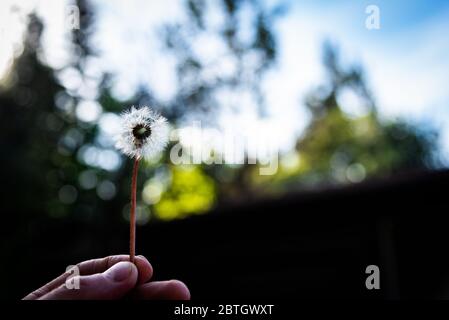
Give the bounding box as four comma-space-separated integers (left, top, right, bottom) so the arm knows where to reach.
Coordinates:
297, 108, 432, 182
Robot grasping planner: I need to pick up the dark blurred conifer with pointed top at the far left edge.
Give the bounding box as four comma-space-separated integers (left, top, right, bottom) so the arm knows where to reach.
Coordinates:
0, 14, 65, 215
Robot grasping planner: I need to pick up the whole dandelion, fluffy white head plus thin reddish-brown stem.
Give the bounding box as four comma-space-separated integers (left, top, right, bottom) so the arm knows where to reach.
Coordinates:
116, 106, 168, 262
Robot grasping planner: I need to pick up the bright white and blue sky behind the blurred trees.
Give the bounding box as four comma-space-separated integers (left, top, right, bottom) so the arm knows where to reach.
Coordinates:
0, 0, 449, 164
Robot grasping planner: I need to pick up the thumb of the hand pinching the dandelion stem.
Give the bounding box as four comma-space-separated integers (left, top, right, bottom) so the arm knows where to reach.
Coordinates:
40, 261, 138, 300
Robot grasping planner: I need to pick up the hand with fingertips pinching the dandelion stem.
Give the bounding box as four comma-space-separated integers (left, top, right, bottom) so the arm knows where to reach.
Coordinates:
23, 255, 190, 300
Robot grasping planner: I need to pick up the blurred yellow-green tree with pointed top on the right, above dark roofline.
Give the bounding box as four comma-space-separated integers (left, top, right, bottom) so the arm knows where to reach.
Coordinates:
259, 43, 437, 191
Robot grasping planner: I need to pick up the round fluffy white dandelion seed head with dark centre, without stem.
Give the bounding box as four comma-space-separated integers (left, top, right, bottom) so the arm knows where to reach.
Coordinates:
116, 106, 168, 160
